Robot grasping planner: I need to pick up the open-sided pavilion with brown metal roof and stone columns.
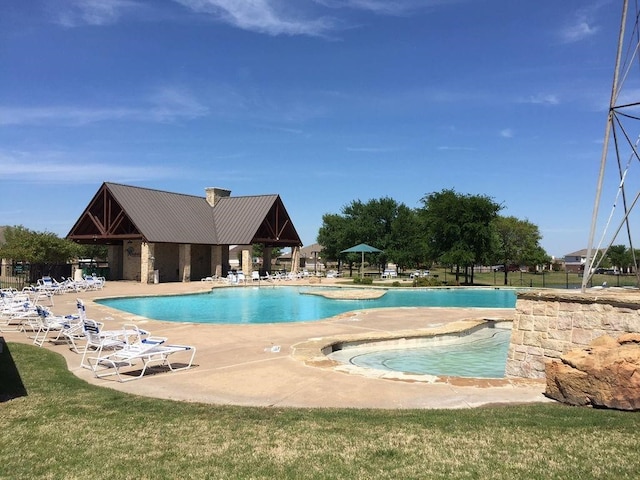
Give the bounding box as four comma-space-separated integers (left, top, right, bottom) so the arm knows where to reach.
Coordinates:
67, 182, 302, 283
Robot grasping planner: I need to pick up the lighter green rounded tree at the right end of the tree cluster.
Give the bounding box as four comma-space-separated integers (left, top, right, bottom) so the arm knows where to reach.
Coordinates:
493, 216, 549, 285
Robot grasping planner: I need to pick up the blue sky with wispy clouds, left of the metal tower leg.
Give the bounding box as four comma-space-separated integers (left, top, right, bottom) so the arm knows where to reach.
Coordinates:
0, 0, 622, 256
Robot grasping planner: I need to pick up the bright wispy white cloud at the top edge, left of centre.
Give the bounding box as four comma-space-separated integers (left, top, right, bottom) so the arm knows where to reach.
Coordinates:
174, 0, 335, 36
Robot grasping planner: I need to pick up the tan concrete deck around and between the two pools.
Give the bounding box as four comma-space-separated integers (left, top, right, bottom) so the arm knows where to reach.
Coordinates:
0, 279, 552, 409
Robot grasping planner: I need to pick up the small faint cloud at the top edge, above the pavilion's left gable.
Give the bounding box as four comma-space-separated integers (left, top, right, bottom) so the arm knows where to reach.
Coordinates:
55, 0, 142, 27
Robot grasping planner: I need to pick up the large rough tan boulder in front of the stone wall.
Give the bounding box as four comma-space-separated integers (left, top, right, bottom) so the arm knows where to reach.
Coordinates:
545, 333, 640, 410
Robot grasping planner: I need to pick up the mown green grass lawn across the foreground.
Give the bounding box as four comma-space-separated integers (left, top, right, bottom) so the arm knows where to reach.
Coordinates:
0, 343, 640, 480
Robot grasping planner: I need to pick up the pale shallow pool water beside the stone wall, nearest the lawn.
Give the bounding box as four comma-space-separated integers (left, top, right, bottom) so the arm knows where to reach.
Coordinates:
329, 328, 511, 378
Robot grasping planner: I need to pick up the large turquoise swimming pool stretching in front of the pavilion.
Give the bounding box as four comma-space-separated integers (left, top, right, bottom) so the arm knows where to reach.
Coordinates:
96, 286, 516, 324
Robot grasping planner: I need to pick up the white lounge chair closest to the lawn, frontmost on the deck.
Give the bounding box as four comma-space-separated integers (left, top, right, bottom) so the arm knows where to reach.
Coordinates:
87, 337, 196, 382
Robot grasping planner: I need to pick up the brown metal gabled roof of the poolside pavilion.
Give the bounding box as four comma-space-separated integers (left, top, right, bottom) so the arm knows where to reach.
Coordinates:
68, 182, 301, 245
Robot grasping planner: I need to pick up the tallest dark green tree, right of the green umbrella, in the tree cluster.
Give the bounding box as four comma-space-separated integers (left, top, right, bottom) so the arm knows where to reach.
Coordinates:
420, 189, 502, 283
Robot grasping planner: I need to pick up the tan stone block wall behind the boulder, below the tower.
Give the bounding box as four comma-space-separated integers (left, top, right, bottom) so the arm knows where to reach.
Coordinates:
506, 288, 640, 378
